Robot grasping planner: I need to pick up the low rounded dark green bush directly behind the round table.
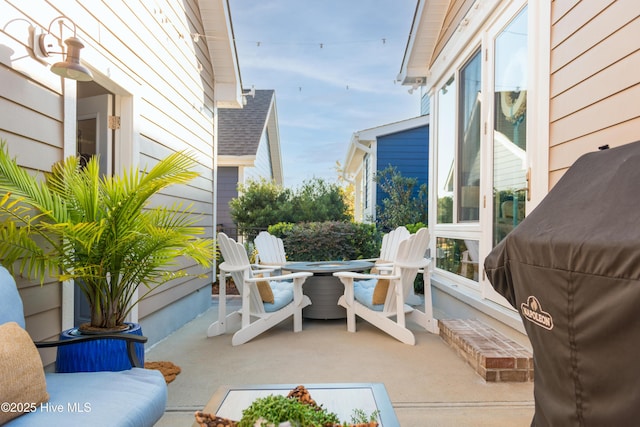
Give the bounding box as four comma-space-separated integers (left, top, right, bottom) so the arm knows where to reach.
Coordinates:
269, 221, 382, 261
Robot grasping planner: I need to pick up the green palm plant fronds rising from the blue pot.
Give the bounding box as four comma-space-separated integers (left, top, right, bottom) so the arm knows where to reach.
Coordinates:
0, 141, 213, 372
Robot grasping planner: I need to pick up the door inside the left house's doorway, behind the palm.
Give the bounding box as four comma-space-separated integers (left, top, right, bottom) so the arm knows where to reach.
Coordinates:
74, 94, 113, 326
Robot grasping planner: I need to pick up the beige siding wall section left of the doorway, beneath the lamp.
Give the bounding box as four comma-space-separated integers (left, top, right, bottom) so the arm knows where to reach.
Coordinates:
0, 1, 64, 366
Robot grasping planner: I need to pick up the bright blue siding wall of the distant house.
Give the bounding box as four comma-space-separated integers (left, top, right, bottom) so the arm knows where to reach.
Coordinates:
376, 126, 429, 217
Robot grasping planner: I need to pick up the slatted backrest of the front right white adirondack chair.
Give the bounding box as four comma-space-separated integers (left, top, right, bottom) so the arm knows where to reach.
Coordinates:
384, 228, 429, 312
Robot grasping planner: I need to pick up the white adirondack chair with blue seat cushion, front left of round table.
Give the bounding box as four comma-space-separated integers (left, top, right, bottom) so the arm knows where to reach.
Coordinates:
207, 233, 313, 345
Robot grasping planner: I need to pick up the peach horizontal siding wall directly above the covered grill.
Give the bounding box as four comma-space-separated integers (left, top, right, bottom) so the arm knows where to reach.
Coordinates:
549, 0, 640, 186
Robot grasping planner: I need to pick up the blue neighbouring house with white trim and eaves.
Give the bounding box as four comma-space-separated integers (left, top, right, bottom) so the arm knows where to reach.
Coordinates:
344, 115, 429, 222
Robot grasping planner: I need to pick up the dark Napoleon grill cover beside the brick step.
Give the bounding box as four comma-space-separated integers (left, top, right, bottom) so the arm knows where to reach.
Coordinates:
484, 142, 640, 426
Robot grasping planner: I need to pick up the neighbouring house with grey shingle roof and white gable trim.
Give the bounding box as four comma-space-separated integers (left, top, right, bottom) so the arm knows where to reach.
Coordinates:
216, 89, 283, 238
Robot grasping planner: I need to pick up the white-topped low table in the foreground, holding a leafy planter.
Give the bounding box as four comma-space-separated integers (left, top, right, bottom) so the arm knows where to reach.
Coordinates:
194, 383, 400, 427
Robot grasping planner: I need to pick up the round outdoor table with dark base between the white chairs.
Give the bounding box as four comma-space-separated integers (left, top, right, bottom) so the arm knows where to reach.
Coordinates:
283, 260, 373, 319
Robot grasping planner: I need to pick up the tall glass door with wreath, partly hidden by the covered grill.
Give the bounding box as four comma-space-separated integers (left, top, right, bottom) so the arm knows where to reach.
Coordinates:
483, 6, 531, 306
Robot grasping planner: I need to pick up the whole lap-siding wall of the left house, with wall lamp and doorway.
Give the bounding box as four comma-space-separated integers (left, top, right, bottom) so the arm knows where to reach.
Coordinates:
0, 0, 220, 363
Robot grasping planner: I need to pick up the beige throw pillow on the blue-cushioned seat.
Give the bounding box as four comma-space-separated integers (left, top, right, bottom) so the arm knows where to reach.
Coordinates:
0, 322, 49, 424
